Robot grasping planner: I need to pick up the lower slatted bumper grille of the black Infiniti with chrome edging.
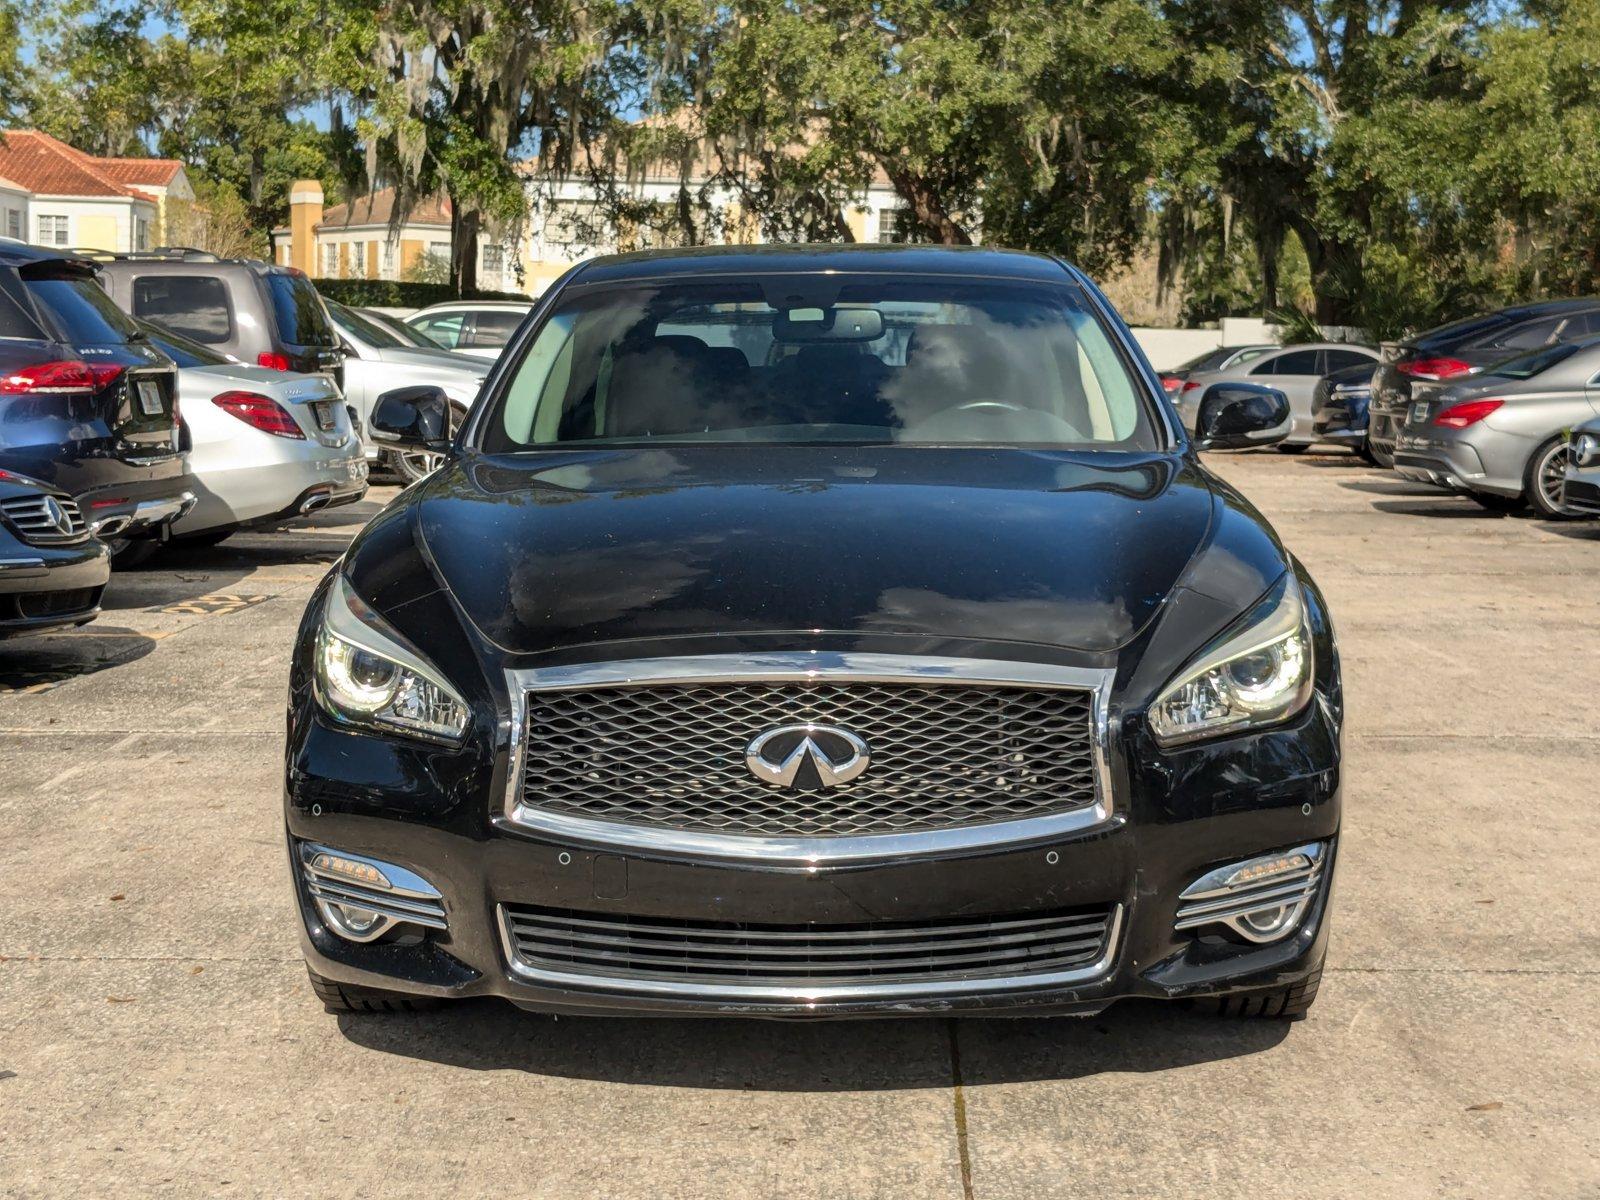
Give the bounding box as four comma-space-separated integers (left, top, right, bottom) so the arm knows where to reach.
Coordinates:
499, 904, 1120, 997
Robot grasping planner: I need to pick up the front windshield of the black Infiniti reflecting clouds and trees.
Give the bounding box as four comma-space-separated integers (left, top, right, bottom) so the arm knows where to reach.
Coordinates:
483, 275, 1160, 453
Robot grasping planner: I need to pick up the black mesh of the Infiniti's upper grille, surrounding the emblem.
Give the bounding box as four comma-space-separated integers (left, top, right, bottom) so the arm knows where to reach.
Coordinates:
517, 677, 1099, 838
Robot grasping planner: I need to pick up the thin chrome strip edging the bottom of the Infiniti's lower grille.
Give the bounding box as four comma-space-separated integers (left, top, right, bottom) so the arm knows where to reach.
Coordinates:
494, 904, 1123, 1005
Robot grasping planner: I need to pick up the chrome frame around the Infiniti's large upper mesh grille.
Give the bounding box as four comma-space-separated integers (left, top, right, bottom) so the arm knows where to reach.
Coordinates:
502, 650, 1115, 867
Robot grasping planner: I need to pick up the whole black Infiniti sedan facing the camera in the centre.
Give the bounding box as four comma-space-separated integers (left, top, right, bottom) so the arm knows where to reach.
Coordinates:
285, 246, 1342, 1018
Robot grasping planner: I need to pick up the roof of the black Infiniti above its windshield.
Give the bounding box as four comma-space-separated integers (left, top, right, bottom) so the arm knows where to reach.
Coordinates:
568, 243, 1070, 286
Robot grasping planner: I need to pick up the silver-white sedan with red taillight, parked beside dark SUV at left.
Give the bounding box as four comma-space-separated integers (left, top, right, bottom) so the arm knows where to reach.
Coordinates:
142, 325, 366, 546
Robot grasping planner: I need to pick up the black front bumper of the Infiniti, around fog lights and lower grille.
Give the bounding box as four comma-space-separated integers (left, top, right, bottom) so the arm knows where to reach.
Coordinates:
286, 699, 1339, 1018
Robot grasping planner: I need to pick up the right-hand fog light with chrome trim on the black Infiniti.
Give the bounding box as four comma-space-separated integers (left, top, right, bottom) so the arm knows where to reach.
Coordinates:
1173, 842, 1326, 942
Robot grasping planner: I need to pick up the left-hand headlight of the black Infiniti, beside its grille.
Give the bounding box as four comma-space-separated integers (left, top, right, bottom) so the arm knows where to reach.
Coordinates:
317, 574, 469, 742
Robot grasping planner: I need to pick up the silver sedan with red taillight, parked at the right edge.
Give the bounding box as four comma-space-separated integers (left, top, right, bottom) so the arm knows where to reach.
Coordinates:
1395, 338, 1600, 518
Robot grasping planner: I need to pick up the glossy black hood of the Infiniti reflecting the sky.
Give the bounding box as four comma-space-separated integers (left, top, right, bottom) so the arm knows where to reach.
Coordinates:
413, 446, 1214, 654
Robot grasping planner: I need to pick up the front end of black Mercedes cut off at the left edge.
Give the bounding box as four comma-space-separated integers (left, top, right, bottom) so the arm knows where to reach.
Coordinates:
0, 470, 110, 638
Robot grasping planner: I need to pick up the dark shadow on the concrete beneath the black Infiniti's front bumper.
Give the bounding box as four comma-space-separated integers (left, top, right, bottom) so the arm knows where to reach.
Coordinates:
339, 1000, 1290, 1091
